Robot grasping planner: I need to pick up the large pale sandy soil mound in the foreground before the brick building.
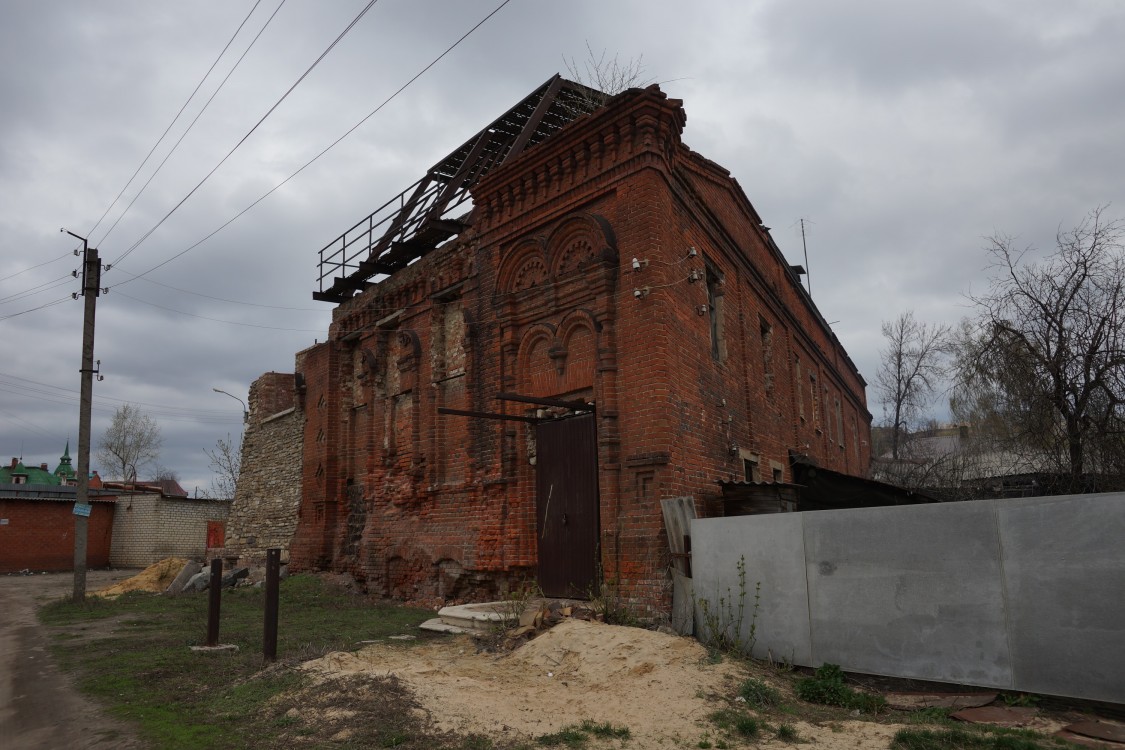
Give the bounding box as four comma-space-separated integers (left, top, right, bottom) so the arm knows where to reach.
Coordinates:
305, 620, 901, 750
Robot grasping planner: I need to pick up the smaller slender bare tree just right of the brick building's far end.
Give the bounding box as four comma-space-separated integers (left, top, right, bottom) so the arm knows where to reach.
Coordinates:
875, 311, 950, 460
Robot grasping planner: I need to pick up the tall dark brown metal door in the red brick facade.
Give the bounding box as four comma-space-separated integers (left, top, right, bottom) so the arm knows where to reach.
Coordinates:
536, 414, 599, 599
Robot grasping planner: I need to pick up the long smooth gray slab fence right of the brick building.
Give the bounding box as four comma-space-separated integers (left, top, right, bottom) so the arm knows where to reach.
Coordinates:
691, 493, 1125, 703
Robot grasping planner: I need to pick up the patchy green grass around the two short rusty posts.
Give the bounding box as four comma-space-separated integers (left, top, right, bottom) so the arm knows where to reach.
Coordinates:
39, 576, 519, 750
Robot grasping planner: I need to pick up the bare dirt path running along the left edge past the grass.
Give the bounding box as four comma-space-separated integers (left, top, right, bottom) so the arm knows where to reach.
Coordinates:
0, 570, 145, 750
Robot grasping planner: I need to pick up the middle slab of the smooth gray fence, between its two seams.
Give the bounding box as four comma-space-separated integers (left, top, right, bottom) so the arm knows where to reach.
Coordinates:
800, 503, 1011, 688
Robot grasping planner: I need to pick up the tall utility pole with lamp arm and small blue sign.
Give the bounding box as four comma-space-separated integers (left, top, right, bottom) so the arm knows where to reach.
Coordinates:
66, 229, 101, 602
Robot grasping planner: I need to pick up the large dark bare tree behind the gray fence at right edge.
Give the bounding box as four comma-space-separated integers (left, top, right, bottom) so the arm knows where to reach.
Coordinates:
959, 208, 1125, 491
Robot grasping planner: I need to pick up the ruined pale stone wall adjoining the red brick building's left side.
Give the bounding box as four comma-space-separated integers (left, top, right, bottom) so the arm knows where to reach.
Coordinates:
219, 372, 305, 566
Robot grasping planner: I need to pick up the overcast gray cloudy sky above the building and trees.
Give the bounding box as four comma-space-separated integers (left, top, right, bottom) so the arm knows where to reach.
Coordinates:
0, 0, 1125, 493
